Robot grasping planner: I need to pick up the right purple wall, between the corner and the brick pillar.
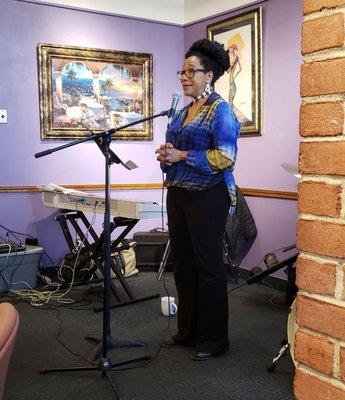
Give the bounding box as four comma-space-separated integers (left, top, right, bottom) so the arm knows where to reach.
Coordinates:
185, 0, 302, 276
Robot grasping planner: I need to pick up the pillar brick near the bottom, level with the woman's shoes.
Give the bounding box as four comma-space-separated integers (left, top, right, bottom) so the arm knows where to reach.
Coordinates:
294, 331, 334, 375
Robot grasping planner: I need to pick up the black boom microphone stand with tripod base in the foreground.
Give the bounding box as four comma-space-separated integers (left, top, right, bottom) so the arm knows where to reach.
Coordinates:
35, 110, 170, 399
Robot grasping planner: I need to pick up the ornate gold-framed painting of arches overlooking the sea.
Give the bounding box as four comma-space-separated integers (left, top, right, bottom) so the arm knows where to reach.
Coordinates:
38, 43, 152, 140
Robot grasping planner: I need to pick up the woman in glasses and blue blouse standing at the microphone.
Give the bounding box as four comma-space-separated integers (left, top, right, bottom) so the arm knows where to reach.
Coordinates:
156, 39, 240, 360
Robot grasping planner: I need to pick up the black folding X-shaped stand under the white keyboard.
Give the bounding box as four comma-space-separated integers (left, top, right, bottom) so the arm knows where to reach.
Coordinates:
55, 210, 159, 312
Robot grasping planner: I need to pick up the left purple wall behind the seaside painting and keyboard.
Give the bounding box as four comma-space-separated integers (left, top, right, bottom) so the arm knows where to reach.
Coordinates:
0, 0, 184, 260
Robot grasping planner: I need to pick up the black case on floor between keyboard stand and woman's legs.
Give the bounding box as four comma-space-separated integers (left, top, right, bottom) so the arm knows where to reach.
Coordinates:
133, 231, 172, 271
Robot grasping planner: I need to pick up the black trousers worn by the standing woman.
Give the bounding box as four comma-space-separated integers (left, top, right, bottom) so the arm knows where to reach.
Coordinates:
167, 181, 230, 352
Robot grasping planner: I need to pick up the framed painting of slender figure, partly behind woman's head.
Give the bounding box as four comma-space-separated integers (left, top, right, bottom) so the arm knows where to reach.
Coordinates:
207, 8, 262, 136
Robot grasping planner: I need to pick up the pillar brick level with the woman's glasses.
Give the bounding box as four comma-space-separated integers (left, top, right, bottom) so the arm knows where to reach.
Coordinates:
301, 58, 345, 97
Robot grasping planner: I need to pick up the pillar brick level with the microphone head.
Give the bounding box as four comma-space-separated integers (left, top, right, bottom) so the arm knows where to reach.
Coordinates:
300, 101, 344, 136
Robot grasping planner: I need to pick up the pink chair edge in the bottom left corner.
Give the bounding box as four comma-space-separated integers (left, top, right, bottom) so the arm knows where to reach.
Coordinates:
0, 303, 19, 400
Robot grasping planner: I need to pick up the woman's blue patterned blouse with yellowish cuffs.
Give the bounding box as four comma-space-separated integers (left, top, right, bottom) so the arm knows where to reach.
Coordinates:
162, 93, 240, 206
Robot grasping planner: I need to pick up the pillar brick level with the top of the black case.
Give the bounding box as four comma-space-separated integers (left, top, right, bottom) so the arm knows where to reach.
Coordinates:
297, 219, 345, 258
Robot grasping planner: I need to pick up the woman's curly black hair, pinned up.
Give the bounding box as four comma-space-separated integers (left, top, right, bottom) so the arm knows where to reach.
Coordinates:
185, 39, 230, 85
